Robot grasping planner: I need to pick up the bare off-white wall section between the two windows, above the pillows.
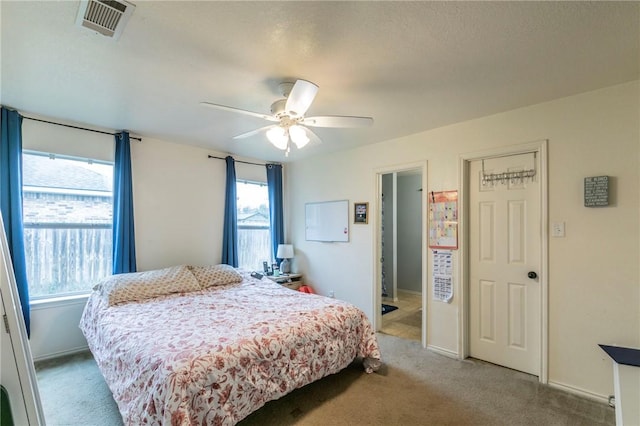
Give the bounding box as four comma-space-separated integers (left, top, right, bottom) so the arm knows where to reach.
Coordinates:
131, 138, 226, 271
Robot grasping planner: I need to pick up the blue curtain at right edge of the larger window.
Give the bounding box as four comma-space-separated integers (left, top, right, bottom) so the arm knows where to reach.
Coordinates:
113, 132, 136, 274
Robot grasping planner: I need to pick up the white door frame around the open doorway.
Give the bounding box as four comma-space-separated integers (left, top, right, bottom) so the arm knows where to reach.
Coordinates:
371, 160, 429, 348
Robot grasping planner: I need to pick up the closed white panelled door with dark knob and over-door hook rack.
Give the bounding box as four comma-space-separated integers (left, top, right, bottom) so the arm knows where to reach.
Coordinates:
469, 153, 541, 376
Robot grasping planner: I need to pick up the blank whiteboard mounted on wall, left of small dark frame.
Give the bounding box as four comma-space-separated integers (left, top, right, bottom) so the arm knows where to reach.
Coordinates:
305, 200, 349, 242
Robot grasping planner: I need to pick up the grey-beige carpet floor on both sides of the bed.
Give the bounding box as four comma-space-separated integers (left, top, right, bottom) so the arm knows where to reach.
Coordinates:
36, 334, 615, 426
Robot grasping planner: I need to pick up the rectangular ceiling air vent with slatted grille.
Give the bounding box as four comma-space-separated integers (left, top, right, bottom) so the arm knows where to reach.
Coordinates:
76, 0, 135, 40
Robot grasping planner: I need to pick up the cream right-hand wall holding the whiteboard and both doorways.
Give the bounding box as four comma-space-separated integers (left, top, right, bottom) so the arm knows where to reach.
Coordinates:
287, 81, 640, 398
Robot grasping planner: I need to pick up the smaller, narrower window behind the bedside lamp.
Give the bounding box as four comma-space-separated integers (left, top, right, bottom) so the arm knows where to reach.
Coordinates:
236, 181, 273, 271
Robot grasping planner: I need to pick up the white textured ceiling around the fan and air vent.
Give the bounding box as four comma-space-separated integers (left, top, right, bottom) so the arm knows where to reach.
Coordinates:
0, 0, 640, 161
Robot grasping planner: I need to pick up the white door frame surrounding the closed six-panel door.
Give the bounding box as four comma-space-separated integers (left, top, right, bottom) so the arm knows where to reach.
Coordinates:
458, 139, 549, 384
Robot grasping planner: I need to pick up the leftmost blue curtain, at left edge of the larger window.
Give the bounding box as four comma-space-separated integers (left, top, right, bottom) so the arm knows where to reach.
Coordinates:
0, 107, 31, 336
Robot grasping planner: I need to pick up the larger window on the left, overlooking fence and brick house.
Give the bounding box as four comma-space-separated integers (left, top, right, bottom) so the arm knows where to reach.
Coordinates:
22, 151, 113, 299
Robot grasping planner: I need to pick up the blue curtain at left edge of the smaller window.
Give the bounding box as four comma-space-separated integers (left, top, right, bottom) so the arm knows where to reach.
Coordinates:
222, 156, 238, 268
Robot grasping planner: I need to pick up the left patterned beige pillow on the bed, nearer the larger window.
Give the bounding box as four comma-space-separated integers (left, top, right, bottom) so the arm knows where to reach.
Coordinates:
98, 265, 201, 306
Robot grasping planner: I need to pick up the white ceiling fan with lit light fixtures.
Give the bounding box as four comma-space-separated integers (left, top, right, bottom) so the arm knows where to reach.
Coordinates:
201, 80, 373, 155
